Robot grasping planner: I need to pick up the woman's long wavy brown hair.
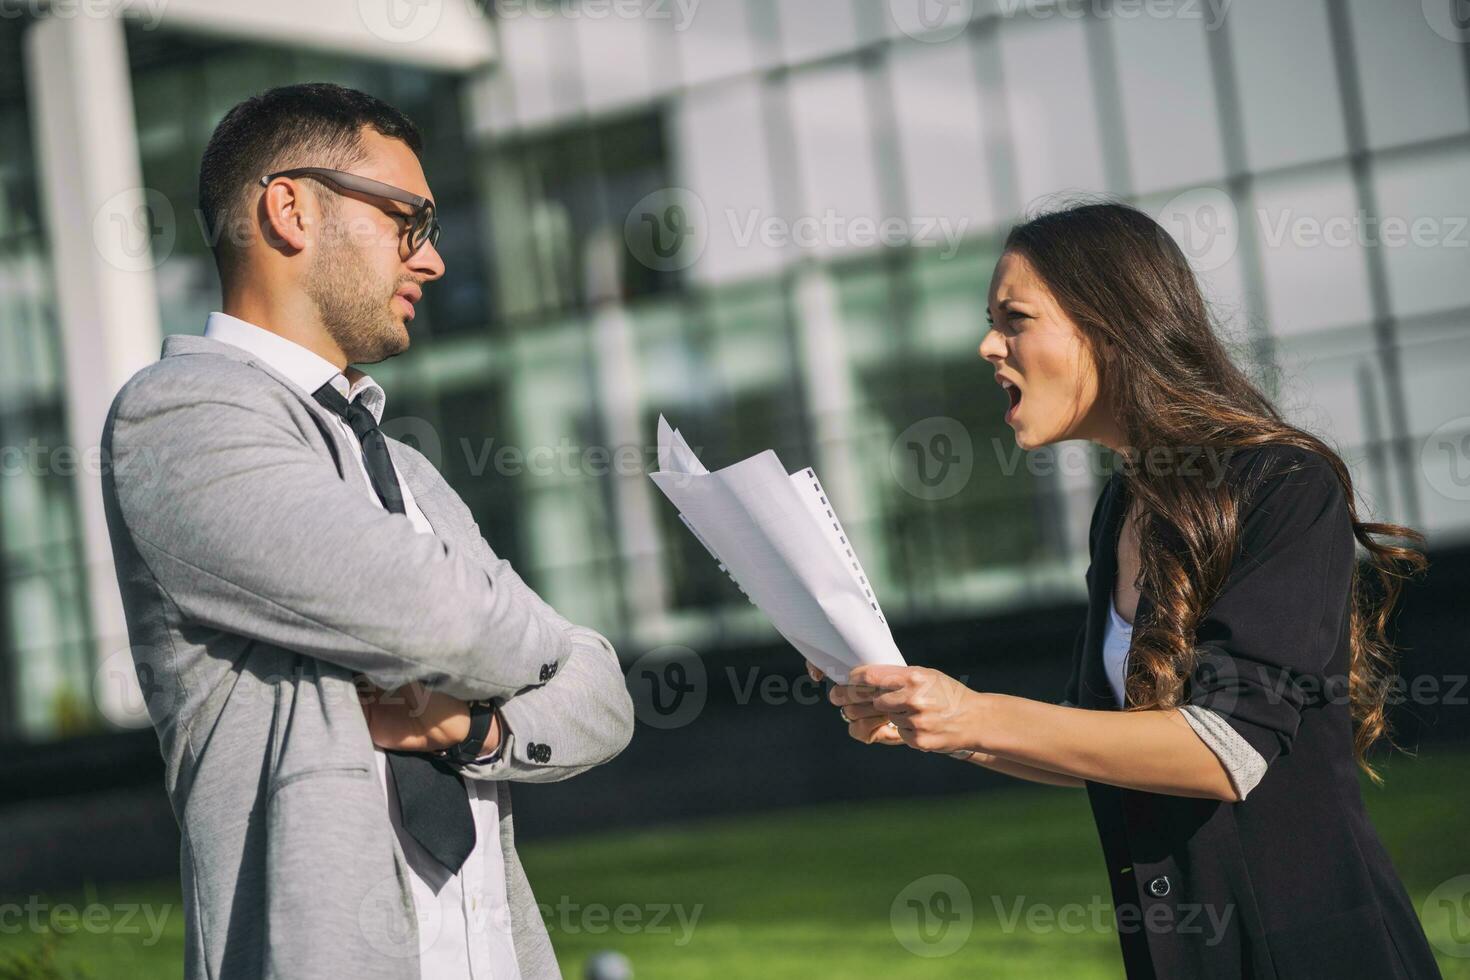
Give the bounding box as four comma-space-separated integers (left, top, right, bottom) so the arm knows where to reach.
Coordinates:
1005, 203, 1426, 782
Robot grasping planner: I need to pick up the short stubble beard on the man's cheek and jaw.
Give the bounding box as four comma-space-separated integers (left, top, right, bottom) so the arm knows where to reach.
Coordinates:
306, 218, 409, 364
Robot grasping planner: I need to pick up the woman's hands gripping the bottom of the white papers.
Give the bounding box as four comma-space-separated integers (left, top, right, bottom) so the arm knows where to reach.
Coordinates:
828, 664, 982, 755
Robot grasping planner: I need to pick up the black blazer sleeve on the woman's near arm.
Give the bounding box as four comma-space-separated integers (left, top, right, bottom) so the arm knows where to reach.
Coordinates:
1188, 453, 1354, 779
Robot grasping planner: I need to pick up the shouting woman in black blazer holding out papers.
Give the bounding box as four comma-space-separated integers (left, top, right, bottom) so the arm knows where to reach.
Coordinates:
831, 204, 1439, 980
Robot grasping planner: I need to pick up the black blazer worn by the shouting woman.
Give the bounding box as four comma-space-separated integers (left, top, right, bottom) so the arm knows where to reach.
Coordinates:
1066, 447, 1439, 980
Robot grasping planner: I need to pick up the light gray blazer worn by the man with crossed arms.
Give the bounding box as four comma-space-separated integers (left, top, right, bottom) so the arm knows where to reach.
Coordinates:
103, 336, 634, 980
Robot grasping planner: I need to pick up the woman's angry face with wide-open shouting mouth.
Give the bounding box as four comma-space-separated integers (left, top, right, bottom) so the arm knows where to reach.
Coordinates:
980, 251, 1117, 450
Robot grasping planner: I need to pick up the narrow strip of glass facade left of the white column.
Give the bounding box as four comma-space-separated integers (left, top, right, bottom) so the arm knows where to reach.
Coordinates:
0, 19, 97, 738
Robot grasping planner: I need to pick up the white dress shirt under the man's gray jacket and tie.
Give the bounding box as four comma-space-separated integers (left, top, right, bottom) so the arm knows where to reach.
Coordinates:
204, 313, 520, 980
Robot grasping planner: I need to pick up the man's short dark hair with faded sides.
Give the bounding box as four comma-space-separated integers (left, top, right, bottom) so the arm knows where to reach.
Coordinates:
198, 82, 423, 279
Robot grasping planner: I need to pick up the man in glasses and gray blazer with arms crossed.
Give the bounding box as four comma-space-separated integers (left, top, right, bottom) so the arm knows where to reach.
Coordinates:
103, 85, 632, 980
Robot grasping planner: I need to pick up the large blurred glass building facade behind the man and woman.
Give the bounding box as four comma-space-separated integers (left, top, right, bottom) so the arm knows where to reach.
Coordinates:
0, 0, 1470, 736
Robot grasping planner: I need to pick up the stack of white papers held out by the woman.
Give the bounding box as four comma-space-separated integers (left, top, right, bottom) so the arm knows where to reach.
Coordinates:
650, 416, 904, 683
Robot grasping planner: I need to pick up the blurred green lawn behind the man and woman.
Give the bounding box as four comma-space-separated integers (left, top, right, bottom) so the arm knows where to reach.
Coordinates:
0, 749, 1470, 980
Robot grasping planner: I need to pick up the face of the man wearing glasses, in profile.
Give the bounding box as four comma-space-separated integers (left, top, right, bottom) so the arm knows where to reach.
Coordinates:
306, 129, 444, 364
